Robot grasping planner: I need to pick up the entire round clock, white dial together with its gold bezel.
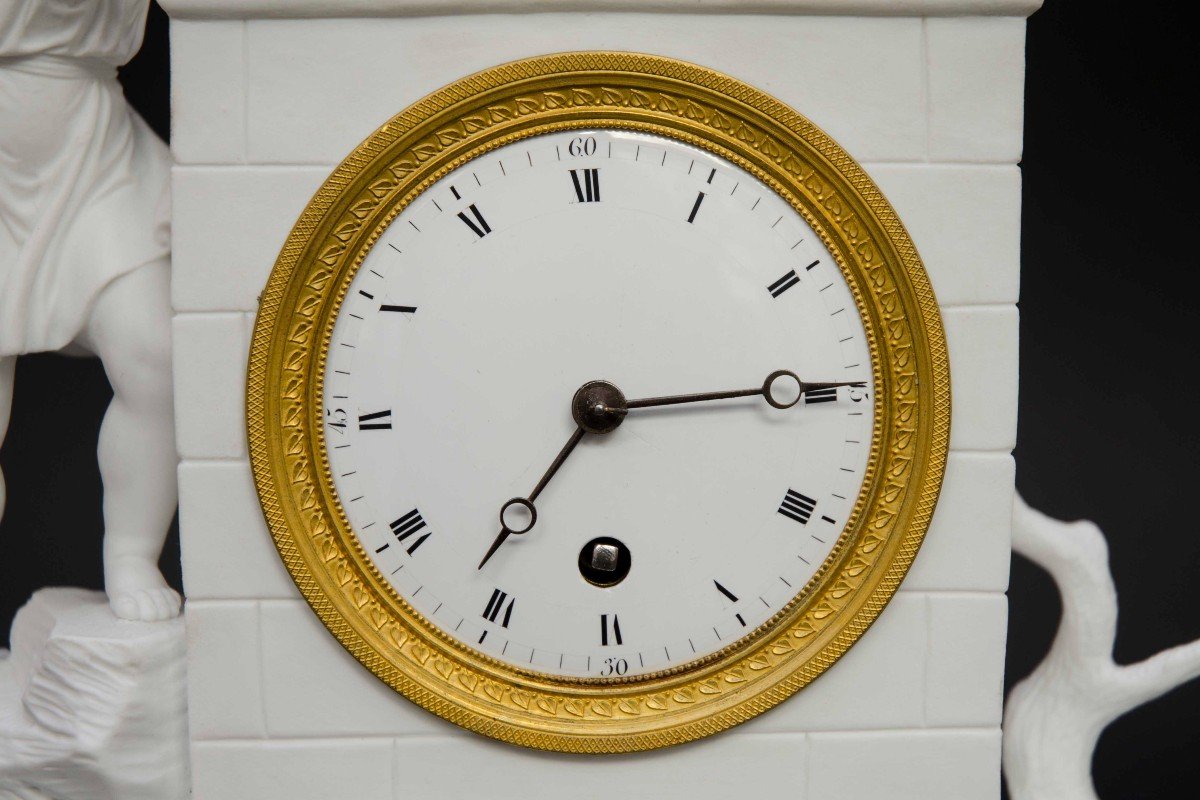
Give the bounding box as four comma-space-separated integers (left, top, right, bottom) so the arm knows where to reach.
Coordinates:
248, 54, 949, 752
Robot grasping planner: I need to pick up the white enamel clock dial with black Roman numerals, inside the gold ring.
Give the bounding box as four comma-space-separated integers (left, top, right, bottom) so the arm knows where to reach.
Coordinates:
324, 130, 874, 679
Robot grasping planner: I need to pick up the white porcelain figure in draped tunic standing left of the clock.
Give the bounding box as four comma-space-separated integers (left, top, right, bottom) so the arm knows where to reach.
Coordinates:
0, 0, 180, 620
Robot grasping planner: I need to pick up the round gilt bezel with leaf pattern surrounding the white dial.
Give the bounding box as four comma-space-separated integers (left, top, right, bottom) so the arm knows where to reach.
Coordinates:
246, 53, 950, 753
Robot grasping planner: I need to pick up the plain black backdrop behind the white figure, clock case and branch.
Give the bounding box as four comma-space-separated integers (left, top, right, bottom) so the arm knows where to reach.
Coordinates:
0, 0, 1200, 800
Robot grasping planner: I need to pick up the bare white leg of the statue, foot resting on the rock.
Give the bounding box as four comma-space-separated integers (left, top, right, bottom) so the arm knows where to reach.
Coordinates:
80, 259, 180, 620
